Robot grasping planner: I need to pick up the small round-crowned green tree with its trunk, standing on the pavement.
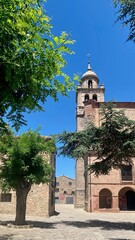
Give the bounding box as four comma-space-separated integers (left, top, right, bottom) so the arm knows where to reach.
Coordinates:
0, 131, 55, 225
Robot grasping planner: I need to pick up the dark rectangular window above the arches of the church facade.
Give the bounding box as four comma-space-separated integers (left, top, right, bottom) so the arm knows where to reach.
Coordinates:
121, 165, 132, 181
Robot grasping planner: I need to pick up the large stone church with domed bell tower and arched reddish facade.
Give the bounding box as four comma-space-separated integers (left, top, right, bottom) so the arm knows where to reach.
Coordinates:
75, 63, 135, 212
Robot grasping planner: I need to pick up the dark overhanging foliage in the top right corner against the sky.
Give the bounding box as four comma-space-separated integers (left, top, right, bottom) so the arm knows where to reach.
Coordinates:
113, 0, 135, 42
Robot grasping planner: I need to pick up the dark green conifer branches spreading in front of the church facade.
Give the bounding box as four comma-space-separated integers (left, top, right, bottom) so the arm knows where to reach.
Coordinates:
58, 103, 135, 176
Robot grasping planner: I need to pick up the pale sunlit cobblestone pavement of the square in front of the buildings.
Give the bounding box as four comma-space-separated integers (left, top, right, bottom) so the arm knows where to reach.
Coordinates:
0, 204, 135, 240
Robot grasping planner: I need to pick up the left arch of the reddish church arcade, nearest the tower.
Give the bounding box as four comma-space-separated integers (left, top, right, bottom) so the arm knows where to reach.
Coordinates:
99, 188, 112, 208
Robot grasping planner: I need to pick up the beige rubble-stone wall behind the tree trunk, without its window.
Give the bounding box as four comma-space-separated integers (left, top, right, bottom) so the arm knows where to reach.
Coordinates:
0, 184, 55, 217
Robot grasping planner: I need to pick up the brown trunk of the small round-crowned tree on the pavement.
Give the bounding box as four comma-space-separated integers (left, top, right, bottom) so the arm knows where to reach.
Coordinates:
15, 183, 31, 225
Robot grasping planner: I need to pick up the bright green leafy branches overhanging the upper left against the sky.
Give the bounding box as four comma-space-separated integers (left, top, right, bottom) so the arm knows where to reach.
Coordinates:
0, 0, 74, 129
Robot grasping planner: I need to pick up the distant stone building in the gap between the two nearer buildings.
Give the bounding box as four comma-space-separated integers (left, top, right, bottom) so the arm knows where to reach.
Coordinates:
55, 176, 75, 204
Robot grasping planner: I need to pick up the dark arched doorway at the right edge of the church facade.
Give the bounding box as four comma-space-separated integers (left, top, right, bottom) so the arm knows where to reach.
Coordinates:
119, 187, 135, 211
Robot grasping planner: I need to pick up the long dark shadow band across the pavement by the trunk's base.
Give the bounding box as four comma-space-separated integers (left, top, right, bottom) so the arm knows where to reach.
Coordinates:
0, 220, 135, 232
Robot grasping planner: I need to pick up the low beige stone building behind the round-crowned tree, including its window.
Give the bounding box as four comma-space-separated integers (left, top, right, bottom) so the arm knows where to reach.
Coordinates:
0, 154, 55, 217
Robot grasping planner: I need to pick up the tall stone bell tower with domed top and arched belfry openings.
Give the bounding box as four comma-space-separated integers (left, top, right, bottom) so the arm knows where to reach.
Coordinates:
75, 61, 105, 208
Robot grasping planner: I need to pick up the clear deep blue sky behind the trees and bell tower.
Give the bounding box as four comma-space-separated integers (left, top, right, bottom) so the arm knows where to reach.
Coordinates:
18, 0, 135, 178
